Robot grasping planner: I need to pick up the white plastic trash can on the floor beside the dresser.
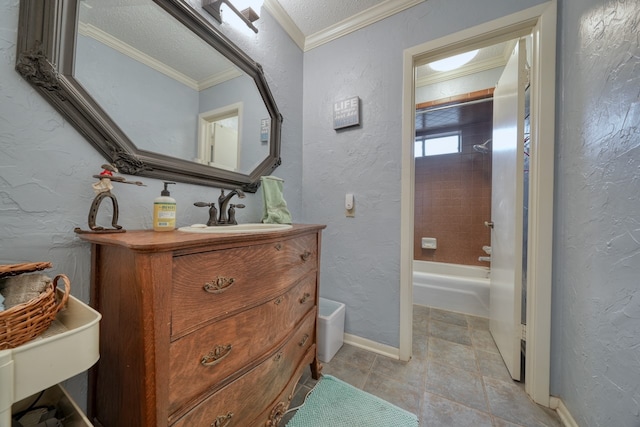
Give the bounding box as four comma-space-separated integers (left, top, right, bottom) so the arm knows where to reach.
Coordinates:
318, 298, 345, 363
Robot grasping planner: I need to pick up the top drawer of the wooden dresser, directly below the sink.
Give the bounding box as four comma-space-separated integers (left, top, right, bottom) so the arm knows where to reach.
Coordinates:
171, 235, 318, 336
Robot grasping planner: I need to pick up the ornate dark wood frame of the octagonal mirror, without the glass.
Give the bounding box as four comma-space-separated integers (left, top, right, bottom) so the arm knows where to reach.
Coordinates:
16, 0, 282, 192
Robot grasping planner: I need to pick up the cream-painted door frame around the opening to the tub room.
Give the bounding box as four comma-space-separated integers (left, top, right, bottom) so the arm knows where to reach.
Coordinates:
399, 0, 557, 407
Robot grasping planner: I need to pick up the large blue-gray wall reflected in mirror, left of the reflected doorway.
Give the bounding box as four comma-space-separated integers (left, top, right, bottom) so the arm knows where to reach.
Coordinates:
74, 36, 201, 160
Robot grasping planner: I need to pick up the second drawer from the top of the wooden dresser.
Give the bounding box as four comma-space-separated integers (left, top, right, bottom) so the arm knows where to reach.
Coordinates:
169, 273, 316, 413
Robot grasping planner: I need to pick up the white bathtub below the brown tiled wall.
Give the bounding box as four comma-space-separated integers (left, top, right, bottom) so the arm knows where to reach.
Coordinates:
413, 261, 489, 317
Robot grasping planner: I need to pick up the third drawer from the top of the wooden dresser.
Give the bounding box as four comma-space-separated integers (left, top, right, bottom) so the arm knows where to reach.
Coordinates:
174, 309, 317, 427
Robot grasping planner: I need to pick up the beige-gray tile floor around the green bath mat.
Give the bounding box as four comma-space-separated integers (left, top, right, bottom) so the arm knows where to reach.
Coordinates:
281, 305, 562, 427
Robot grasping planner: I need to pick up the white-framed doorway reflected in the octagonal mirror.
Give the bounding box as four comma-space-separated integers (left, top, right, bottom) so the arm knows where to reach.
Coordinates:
197, 104, 242, 171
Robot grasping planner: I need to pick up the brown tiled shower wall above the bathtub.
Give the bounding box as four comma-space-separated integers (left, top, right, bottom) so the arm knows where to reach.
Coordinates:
414, 121, 492, 266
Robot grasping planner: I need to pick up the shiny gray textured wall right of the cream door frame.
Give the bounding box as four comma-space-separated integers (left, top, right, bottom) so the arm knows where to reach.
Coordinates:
551, 0, 640, 426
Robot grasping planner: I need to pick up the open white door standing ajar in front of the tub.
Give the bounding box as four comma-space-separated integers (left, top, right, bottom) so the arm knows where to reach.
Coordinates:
489, 39, 526, 380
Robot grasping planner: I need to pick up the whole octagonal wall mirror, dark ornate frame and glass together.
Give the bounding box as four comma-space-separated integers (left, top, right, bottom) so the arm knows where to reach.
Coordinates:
16, 0, 282, 192
